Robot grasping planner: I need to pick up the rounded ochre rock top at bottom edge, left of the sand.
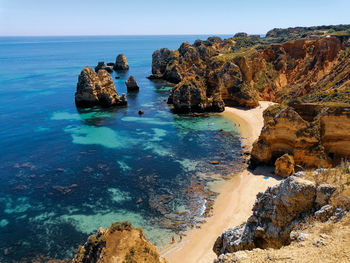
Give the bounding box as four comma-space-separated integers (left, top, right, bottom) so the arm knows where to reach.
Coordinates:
72, 222, 166, 263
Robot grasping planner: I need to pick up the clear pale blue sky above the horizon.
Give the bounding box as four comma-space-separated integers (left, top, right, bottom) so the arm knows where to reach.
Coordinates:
0, 0, 350, 36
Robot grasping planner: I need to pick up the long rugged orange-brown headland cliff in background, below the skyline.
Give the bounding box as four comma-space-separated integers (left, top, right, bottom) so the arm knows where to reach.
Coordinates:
150, 29, 350, 112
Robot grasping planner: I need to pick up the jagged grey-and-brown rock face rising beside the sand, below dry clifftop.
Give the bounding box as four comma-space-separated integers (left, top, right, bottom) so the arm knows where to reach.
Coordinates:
213, 176, 334, 255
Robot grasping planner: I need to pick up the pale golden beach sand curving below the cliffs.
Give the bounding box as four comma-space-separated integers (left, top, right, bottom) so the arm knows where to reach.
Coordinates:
161, 101, 278, 263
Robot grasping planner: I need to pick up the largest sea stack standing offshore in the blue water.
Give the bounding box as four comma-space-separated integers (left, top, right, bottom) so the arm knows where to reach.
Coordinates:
75, 67, 127, 107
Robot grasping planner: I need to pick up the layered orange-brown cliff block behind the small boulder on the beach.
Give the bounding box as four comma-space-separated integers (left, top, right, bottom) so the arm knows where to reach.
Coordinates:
251, 104, 350, 167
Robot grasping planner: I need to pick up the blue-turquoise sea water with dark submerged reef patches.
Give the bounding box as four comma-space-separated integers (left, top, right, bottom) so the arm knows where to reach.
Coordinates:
0, 36, 241, 262
